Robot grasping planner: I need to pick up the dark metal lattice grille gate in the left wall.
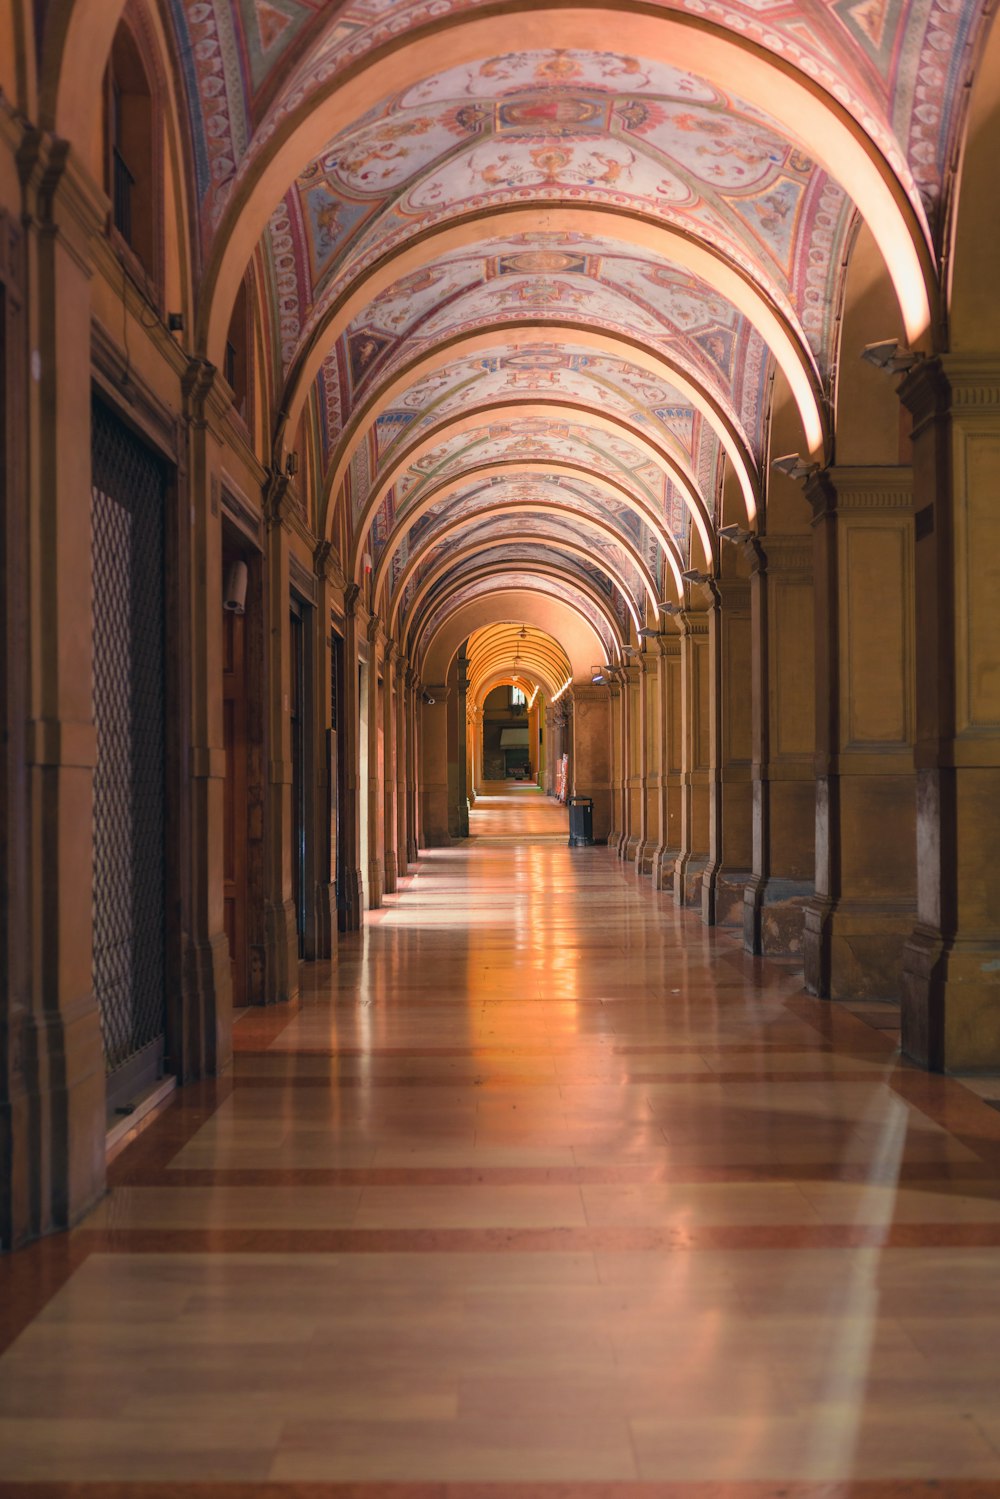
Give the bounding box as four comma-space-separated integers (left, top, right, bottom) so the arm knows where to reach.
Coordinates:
91, 400, 166, 1106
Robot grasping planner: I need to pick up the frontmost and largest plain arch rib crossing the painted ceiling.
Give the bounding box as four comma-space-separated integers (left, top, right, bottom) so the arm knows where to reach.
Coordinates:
199, 0, 936, 380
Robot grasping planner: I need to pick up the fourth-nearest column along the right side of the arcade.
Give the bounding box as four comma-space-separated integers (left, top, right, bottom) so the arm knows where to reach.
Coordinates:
702, 572, 753, 928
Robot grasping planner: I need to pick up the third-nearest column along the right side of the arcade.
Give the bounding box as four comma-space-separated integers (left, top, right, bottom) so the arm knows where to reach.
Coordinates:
744, 534, 816, 955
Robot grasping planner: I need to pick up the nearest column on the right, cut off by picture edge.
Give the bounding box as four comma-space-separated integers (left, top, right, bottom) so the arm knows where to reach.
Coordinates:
900, 357, 1000, 1070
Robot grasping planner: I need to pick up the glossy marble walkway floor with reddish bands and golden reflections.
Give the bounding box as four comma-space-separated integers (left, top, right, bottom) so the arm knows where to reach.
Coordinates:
0, 788, 1000, 1499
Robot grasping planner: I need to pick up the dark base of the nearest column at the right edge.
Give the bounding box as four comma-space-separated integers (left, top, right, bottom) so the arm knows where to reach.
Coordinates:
901, 925, 1000, 1072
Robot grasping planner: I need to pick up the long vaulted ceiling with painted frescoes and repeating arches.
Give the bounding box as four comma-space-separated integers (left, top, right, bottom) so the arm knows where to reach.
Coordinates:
144, 0, 979, 680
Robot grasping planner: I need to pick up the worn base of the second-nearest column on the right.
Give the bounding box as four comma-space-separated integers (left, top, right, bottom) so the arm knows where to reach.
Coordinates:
802, 895, 916, 1000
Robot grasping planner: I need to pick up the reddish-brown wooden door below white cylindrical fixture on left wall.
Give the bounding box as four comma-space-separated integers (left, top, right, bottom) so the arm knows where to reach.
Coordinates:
222, 610, 249, 1009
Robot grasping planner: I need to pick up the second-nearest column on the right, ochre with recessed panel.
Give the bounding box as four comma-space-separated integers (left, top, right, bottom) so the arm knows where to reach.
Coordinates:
804, 468, 916, 1000
